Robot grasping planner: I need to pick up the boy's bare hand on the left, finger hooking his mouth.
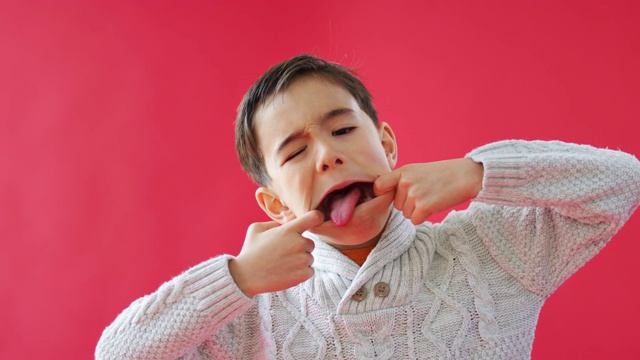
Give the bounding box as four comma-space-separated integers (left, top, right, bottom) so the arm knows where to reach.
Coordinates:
229, 210, 324, 298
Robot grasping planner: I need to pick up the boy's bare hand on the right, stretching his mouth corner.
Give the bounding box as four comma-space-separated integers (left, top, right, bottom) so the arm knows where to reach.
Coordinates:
373, 158, 484, 225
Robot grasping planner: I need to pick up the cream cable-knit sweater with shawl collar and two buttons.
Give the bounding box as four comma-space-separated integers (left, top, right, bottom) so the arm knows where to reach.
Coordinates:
96, 141, 640, 360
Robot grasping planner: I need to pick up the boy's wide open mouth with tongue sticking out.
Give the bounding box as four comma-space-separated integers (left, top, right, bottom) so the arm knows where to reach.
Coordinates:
317, 182, 376, 227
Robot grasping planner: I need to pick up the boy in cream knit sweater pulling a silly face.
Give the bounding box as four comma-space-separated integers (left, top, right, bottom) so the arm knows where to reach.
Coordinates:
96, 55, 640, 359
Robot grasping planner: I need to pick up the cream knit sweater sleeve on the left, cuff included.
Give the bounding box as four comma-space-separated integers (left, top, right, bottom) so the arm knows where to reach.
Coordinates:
95, 255, 254, 359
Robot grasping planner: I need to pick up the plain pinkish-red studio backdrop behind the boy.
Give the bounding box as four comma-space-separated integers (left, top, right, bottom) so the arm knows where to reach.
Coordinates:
0, 0, 640, 359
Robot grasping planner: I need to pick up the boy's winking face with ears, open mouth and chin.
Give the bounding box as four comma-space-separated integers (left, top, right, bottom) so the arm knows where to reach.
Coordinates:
254, 75, 397, 248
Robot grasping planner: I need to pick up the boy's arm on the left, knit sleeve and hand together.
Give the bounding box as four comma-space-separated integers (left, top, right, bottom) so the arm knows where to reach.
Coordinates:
96, 211, 323, 359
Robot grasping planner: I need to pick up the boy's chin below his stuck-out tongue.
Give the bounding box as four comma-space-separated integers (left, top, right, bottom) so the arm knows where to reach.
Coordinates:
311, 193, 394, 246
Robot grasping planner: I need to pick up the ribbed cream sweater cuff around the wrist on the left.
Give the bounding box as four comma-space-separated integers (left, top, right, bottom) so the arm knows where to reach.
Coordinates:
183, 255, 254, 318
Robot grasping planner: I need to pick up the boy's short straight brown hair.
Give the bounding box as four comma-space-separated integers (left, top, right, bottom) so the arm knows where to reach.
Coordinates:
236, 54, 378, 186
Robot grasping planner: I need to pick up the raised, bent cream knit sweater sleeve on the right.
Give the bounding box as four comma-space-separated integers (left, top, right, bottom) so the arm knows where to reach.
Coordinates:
467, 140, 640, 296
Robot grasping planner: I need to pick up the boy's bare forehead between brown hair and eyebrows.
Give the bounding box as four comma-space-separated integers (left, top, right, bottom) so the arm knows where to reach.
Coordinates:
254, 75, 362, 148
